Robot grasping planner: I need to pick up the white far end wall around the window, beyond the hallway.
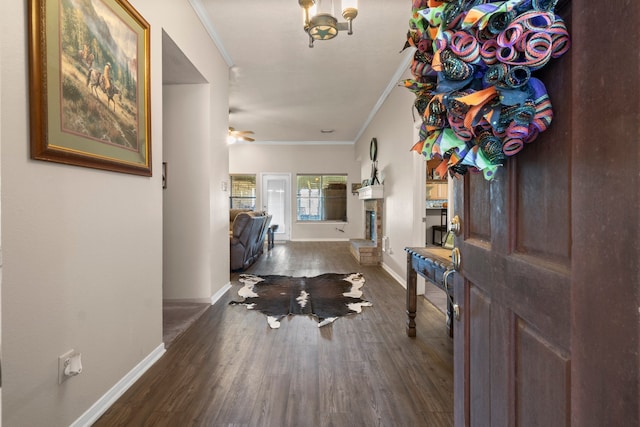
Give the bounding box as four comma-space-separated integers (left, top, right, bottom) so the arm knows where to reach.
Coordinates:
229, 144, 368, 240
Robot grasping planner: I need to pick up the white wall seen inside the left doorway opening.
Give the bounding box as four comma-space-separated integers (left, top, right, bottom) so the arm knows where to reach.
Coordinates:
163, 84, 211, 302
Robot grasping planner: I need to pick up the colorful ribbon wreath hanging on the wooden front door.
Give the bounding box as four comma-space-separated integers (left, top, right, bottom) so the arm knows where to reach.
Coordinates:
403, 0, 570, 180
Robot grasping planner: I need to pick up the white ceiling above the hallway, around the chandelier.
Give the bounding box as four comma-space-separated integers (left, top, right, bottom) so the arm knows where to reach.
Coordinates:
188, 0, 411, 143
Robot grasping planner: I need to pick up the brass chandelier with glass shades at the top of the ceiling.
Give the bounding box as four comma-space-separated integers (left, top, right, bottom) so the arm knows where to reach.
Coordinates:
298, 0, 358, 47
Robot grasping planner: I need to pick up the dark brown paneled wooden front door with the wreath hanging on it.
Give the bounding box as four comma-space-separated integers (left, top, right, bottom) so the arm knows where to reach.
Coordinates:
454, 0, 640, 426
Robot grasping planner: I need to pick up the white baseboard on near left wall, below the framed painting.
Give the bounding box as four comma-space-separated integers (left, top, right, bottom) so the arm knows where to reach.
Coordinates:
70, 344, 166, 427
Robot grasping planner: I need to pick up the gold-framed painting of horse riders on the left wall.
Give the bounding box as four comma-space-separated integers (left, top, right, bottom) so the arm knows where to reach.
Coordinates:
29, 0, 151, 176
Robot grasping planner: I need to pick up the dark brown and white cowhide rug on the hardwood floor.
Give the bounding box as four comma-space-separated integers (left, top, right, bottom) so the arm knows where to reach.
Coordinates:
230, 273, 372, 328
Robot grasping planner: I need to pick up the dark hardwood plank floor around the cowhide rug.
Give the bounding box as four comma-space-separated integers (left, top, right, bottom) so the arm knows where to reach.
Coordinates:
94, 242, 453, 427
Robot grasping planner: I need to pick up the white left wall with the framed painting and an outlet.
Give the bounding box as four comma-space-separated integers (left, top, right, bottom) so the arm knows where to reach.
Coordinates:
0, 0, 229, 426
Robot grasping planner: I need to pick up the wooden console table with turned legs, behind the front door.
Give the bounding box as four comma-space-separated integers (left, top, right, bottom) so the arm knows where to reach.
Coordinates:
404, 247, 454, 337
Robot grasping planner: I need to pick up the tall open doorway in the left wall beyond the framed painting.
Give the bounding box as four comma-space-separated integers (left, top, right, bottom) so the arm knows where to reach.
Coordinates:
162, 31, 211, 348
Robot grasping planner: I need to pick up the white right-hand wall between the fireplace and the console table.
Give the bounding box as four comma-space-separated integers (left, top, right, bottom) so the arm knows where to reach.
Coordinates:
356, 78, 425, 279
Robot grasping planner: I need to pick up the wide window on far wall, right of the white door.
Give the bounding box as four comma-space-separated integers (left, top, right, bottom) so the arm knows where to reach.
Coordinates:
296, 175, 347, 221
